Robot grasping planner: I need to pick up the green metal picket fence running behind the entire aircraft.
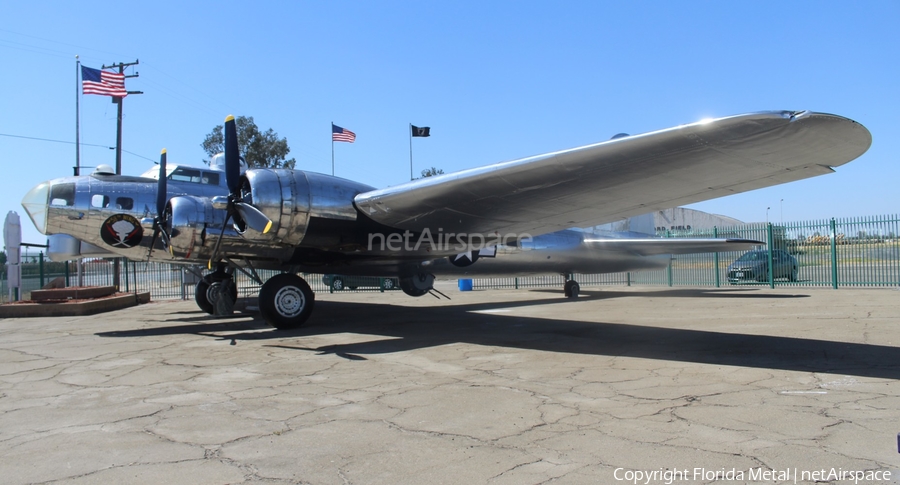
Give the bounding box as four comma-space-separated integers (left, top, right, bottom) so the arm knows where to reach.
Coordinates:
0, 215, 900, 301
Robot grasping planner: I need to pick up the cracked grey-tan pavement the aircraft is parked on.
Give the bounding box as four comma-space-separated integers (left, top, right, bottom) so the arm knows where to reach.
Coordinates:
0, 287, 900, 485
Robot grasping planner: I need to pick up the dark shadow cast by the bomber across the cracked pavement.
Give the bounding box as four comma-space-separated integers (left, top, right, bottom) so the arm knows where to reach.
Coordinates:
97, 290, 900, 379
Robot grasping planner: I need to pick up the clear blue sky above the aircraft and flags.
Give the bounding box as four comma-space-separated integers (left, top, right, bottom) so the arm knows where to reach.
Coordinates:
0, 1, 900, 246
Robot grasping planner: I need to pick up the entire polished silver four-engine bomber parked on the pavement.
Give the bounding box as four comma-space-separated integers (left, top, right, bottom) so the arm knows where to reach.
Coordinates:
15, 111, 872, 329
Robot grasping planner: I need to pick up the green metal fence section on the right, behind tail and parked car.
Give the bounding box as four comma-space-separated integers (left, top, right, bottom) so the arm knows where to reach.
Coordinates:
473, 215, 900, 289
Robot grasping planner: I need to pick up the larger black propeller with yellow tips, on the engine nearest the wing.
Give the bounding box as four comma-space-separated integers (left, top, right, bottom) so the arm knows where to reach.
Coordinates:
209, 115, 272, 269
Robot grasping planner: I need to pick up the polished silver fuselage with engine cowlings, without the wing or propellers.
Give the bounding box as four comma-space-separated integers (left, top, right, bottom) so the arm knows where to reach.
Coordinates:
24, 163, 668, 277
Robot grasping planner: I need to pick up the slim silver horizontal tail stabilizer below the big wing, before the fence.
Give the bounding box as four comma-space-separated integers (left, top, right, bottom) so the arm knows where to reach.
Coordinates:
584, 238, 765, 256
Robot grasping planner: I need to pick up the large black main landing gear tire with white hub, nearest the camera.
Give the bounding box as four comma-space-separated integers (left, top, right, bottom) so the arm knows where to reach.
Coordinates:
259, 273, 316, 330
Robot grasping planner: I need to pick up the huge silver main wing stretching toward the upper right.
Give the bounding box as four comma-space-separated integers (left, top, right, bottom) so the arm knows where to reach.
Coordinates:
354, 111, 872, 236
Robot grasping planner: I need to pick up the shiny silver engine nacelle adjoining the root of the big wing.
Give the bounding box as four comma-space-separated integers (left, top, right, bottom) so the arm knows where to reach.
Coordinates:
235, 169, 373, 246
